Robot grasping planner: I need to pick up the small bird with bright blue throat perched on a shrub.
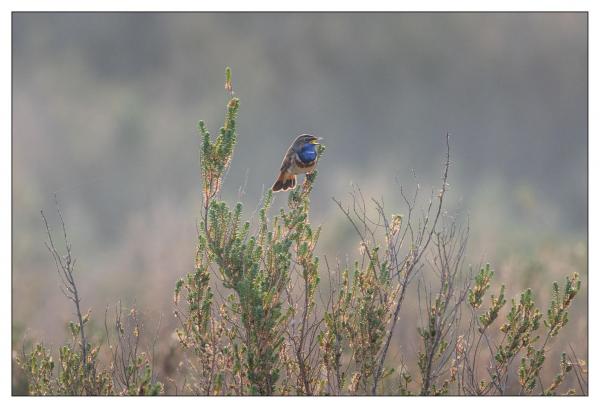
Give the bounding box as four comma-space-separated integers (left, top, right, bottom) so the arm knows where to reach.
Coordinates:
272, 134, 321, 191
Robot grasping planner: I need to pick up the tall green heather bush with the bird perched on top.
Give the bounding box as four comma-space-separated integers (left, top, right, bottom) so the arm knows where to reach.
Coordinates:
175, 69, 323, 395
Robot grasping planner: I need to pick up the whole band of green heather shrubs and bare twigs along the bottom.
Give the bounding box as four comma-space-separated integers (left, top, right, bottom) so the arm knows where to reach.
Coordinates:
16, 69, 587, 395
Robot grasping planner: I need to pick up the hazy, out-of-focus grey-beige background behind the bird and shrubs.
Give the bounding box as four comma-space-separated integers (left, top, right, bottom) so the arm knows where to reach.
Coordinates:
12, 13, 588, 392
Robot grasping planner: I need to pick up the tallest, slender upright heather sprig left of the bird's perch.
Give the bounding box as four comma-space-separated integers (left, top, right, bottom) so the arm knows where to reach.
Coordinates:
174, 67, 243, 395
